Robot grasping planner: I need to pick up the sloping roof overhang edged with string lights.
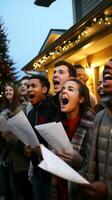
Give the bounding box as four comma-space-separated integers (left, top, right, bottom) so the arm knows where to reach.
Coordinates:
22, 0, 112, 71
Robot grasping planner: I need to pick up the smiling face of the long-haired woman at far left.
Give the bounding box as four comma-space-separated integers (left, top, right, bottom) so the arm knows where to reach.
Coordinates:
5, 86, 14, 102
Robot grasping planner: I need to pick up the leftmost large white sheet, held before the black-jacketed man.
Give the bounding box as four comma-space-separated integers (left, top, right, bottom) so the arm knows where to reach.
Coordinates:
8, 111, 39, 147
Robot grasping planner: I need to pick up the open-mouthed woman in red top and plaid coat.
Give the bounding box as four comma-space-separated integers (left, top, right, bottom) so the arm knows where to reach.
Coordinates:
52, 79, 94, 200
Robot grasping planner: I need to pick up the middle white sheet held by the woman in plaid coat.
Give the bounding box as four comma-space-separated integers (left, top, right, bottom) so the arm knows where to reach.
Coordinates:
35, 122, 73, 153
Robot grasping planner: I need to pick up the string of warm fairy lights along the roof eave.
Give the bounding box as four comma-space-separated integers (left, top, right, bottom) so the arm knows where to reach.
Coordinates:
33, 14, 112, 69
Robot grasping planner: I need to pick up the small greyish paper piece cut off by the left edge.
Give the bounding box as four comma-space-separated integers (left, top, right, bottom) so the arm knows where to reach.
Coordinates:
0, 116, 9, 132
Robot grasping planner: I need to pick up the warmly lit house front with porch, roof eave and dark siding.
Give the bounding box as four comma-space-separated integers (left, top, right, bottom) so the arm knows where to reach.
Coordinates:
23, 0, 112, 96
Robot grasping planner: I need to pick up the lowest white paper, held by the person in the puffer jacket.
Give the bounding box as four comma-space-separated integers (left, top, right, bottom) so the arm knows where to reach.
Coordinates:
38, 145, 89, 184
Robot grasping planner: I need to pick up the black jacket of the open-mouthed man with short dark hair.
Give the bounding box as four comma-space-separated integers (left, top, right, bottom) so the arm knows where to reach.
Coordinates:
28, 96, 58, 165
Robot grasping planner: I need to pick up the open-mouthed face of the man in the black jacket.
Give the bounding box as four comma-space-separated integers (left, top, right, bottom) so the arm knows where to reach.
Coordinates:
27, 78, 47, 105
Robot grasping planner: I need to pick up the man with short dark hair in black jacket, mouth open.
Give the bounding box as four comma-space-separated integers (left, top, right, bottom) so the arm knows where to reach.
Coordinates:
25, 75, 57, 200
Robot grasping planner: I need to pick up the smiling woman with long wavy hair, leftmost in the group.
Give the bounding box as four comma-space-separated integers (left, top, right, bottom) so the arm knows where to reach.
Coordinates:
0, 83, 33, 200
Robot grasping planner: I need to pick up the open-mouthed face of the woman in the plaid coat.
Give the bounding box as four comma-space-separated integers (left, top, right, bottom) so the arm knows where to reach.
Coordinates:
59, 80, 84, 115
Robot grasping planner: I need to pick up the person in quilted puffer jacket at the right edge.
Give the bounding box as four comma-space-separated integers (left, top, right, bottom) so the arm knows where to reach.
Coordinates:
79, 59, 112, 200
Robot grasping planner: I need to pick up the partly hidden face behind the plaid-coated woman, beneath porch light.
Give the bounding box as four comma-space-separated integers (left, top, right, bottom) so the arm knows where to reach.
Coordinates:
76, 68, 88, 85
